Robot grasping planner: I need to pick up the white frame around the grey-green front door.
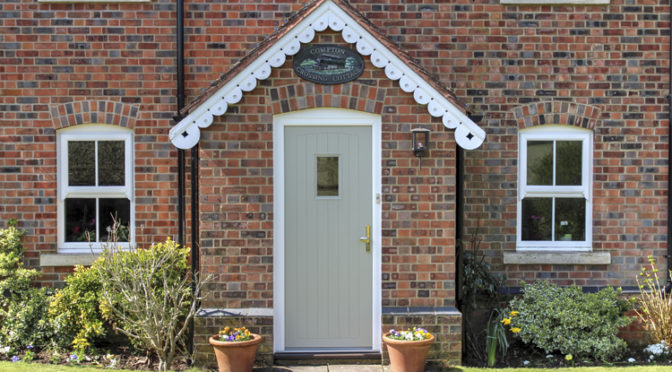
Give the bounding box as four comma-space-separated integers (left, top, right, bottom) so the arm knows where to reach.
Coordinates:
273, 108, 382, 352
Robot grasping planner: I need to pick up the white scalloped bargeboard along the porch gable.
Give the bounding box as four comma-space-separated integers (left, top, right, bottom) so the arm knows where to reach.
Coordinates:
169, 1, 485, 150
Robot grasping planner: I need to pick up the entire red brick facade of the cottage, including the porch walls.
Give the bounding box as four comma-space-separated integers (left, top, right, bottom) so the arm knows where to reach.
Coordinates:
0, 0, 669, 360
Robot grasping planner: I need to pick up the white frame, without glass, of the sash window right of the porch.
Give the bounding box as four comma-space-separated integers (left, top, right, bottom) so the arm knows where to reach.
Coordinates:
516, 125, 593, 251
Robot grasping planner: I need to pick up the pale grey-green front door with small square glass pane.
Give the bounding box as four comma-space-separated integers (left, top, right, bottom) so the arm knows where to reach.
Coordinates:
284, 126, 373, 351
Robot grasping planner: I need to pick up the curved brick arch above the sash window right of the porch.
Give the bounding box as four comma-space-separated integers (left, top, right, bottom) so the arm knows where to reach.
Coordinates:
513, 101, 602, 129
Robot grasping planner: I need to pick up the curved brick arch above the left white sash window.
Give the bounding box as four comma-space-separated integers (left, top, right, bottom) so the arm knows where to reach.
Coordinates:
50, 100, 140, 129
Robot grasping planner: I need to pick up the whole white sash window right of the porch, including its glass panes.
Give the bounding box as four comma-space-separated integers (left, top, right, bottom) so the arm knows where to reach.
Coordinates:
517, 125, 593, 251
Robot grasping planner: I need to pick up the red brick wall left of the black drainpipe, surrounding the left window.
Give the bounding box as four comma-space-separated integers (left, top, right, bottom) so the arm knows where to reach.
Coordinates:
0, 0, 184, 285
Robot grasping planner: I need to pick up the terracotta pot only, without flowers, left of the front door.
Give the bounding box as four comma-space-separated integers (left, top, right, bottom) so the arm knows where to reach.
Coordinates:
208, 333, 262, 372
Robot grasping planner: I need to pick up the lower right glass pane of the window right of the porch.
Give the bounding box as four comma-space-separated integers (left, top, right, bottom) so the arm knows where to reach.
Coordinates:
555, 198, 586, 241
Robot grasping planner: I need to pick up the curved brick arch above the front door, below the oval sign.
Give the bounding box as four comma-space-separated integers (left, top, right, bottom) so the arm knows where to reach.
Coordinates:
270, 83, 385, 114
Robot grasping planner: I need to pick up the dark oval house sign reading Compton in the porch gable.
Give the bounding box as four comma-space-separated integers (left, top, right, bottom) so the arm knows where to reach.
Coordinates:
294, 44, 364, 84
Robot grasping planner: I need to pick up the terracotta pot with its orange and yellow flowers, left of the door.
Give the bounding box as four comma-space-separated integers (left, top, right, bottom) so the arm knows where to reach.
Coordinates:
208, 327, 262, 372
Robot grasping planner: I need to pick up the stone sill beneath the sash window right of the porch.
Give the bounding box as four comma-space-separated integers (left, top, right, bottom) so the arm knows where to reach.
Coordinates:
503, 251, 611, 265
